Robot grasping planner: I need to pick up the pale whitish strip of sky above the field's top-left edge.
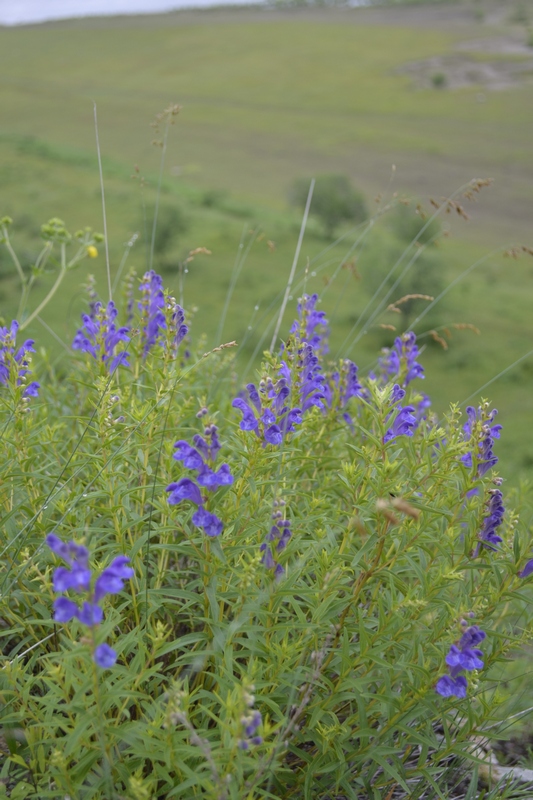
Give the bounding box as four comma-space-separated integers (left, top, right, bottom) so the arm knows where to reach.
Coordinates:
0, 0, 258, 25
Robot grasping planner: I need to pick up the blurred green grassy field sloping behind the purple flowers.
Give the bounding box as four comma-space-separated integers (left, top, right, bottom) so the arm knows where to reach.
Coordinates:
0, 2, 533, 482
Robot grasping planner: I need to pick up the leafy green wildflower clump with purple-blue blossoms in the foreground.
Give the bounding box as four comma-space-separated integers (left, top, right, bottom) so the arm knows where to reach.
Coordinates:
0, 217, 533, 800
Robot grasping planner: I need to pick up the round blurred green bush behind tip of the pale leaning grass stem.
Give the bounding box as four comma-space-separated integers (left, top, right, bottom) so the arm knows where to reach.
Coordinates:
289, 175, 368, 238
